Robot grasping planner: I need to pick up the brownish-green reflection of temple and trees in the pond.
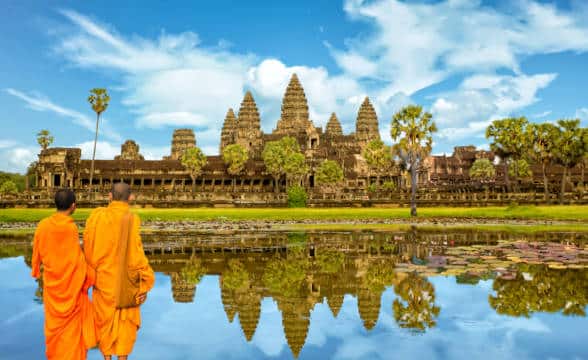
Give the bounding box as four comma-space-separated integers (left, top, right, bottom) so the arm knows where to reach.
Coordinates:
2, 229, 588, 357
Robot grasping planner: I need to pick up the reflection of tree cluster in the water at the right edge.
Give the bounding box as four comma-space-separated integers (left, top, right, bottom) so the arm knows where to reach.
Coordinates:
488, 265, 588, 317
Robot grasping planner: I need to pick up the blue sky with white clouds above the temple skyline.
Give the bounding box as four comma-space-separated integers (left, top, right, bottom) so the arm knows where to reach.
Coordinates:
0, 0, 588, 171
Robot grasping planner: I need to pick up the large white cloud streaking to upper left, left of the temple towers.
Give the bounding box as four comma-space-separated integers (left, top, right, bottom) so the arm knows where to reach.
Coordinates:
55, 11, 254, 151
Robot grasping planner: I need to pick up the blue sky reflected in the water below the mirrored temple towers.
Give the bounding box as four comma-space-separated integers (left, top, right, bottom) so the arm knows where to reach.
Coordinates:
0, 257, 588, 359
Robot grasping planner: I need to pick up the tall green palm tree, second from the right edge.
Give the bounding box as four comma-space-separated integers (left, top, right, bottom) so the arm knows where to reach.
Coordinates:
527, 123, 560, 201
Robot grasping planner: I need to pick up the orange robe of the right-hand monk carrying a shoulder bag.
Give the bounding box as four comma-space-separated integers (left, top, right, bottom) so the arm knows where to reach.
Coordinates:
84, 201, 155, 355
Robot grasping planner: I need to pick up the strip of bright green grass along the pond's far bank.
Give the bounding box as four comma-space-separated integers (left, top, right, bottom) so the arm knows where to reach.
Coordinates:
0, 206, 588, 222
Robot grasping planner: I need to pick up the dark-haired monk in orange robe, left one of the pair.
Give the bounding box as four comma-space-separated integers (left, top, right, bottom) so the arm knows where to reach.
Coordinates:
31, 190, 96, 360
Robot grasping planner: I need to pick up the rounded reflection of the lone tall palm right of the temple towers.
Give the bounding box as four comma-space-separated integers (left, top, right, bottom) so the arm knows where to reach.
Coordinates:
392, 273, 441, 331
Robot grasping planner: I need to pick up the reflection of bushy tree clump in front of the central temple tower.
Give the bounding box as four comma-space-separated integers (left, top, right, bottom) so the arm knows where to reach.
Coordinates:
263, 248, 310, 297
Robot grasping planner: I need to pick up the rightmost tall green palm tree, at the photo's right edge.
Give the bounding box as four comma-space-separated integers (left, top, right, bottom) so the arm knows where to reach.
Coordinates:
555, 119, 587, 203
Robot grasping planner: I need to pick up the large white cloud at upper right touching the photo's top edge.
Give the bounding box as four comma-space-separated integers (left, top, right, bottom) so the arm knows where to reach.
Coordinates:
332, 0, 588, 96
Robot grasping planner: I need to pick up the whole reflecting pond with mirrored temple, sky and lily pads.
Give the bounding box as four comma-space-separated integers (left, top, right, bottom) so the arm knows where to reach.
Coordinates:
0, 228, 588, 359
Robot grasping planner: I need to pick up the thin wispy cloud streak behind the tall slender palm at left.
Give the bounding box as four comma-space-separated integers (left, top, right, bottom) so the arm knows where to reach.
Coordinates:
4, 88, 120, 140
